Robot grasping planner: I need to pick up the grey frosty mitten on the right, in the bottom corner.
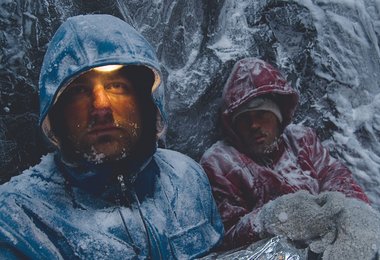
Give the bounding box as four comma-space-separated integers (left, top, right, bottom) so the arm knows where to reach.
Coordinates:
310, 195, 380, 260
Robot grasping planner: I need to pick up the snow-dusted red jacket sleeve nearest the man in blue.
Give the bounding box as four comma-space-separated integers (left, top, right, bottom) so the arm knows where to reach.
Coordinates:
201, 158, 259, 250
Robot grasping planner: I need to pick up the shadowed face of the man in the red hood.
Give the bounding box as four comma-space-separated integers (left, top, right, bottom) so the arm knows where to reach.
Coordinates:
235, 110, 280, 157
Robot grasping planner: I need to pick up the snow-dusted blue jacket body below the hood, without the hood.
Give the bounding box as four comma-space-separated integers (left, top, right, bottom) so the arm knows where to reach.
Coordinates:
0, 149, 223, 259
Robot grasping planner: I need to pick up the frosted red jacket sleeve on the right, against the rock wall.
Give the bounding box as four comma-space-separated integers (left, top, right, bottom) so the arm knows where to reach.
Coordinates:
299, 129, 369, 203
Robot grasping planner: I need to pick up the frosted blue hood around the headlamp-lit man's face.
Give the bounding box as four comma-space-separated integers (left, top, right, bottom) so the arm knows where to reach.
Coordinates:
39, 15, 166, 146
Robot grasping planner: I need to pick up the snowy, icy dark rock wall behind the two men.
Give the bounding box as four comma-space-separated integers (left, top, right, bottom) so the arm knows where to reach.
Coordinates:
0, 0, 380, 208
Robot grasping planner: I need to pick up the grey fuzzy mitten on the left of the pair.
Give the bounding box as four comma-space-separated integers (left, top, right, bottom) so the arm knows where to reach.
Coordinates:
254, 191, 344, 245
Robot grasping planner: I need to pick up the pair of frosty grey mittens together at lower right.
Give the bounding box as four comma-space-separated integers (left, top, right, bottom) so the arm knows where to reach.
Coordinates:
255, 191, 380, 259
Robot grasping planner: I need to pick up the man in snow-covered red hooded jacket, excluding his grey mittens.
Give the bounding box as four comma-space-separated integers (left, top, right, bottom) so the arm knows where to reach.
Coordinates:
201, 58, 368, 249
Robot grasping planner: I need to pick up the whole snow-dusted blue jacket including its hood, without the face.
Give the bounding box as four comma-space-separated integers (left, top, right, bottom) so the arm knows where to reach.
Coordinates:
0, 15, 223, 259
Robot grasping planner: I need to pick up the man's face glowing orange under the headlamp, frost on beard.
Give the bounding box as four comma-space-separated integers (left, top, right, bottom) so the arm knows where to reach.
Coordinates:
54, 70, 142, 162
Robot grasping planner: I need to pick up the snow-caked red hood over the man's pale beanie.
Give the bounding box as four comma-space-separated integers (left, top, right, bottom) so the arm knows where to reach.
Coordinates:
221, 58, 298, 147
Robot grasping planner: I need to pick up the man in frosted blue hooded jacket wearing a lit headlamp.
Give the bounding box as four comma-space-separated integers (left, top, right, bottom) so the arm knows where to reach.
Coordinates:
0, 15, 223, 259
